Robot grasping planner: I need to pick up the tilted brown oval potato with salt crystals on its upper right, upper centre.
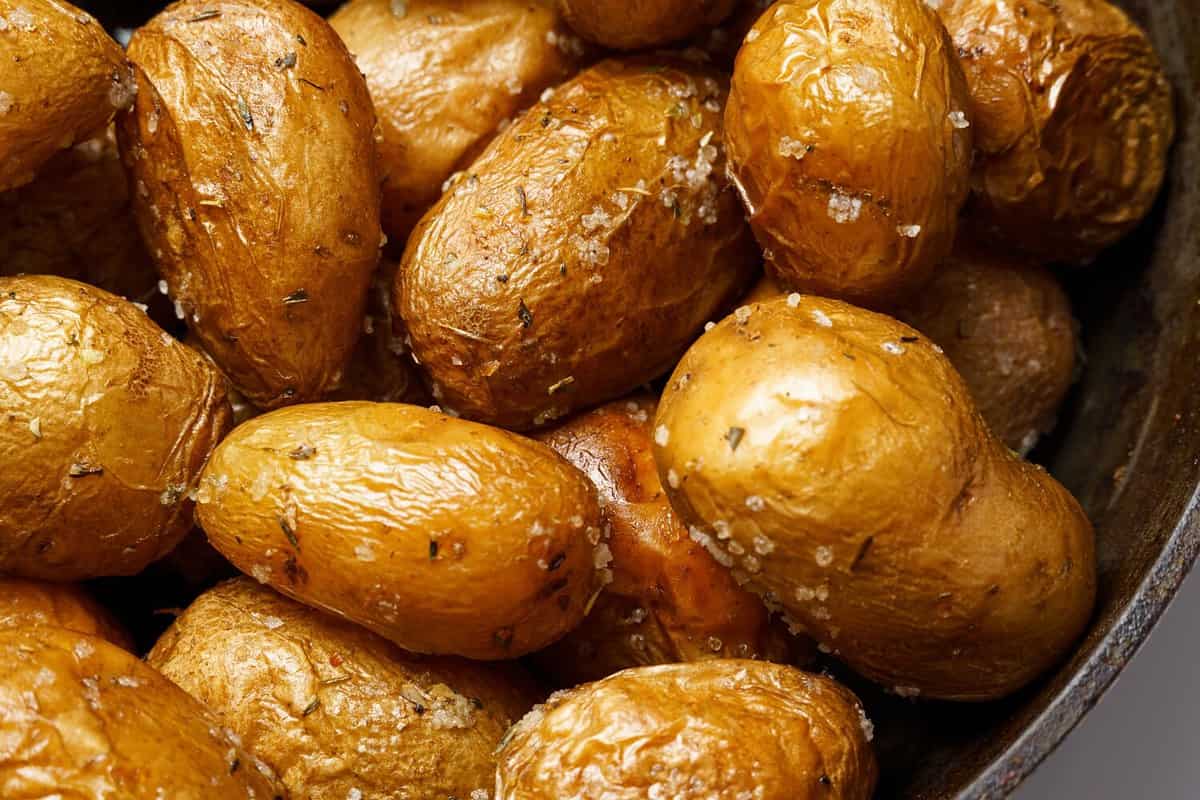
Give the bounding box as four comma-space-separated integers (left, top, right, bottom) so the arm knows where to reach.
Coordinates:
396, 59, 757, 429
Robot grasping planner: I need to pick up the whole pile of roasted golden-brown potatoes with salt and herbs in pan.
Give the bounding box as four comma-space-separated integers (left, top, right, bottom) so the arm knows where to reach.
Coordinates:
0, 0, 1174, 800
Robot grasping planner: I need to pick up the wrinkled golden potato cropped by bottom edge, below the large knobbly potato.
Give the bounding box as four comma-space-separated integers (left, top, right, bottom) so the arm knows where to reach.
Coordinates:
496, 660, 877, 800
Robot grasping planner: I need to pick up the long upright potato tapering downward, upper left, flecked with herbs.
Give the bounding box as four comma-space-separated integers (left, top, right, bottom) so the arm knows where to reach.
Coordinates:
119, 0, 383, 408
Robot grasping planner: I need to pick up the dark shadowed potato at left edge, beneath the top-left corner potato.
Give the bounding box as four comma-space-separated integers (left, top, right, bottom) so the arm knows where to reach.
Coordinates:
0, 127, 160, 313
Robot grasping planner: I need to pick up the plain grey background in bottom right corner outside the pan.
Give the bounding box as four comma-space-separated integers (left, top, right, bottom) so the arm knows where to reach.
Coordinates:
1014, 567, 1200, 800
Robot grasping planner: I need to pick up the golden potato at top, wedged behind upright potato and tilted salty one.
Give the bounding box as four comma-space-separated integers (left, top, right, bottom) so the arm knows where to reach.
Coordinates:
329, 0, 586, 252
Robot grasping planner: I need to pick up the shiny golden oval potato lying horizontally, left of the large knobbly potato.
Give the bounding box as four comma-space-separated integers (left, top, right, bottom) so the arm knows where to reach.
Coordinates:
197, 403, 600, 660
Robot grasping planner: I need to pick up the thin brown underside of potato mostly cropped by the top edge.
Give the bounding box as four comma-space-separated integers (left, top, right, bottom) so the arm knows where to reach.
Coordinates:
558, 0, 737, 50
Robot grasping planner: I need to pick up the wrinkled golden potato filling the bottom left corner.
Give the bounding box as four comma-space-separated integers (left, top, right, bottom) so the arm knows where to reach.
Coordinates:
0, 627, 283, 800
